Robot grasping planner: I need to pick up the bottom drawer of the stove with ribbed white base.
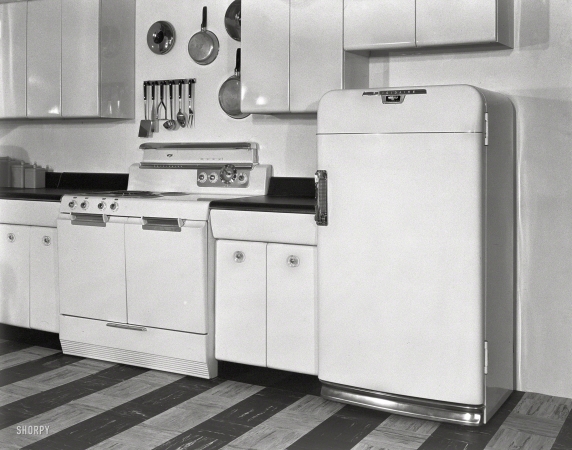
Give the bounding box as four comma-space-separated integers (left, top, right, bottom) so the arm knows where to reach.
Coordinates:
60, 315, 216, 378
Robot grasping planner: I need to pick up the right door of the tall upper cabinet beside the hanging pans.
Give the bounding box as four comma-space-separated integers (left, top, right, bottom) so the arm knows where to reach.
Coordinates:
290, 0, 344, 112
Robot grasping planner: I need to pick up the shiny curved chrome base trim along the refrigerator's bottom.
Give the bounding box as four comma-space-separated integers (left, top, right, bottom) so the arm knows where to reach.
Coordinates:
320, 380, 485, 426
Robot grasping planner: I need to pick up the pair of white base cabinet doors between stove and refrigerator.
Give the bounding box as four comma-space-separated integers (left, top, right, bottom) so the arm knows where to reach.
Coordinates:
215, 240, 317, 374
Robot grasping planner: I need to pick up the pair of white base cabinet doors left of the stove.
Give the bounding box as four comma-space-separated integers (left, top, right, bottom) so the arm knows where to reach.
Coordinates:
0, 224, 59, 333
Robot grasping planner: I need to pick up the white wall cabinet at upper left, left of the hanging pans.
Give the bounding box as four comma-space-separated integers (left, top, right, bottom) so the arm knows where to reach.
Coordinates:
0, 0, 135, 118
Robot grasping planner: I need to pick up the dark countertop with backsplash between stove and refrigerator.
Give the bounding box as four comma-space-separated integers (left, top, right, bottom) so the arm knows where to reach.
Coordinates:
210, 177, 316, 214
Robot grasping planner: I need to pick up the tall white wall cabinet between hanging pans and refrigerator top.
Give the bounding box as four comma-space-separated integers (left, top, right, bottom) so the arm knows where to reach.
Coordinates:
241, 0, 369, 114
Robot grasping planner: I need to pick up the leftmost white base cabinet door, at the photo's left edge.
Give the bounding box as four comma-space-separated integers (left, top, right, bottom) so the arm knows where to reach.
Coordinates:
0, 225, 30, 327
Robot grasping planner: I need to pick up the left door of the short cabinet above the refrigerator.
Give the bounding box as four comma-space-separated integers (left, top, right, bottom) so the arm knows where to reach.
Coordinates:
344, 0, 414, 50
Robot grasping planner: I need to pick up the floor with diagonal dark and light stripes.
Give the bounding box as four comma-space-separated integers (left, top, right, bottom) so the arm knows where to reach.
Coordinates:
0, 339, 572, 450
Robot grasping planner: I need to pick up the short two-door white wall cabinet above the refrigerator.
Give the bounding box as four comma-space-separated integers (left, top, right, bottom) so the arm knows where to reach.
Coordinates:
344, 0, 514, 51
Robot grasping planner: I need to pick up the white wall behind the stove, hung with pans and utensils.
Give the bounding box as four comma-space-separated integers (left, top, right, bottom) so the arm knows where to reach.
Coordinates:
0, 0, 317, 177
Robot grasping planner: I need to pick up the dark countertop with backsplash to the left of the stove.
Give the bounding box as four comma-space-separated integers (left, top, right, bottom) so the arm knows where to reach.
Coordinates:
0, 172, 129, 202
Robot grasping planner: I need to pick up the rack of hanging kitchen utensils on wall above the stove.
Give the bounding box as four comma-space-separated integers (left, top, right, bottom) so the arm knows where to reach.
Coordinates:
143, 78, 197, 132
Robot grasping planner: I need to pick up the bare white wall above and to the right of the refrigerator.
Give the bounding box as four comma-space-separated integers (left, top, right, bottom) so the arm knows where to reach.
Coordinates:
370, 0, 572, 397
